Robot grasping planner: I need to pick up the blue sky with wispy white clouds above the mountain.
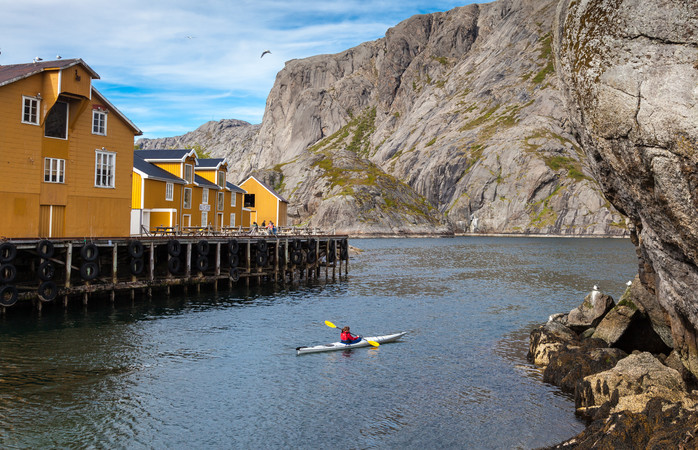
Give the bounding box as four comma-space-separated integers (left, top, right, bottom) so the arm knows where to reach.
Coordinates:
0, 0, 473, 138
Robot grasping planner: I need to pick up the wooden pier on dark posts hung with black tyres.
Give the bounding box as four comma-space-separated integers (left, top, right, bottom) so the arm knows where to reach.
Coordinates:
0, 235, 349, 314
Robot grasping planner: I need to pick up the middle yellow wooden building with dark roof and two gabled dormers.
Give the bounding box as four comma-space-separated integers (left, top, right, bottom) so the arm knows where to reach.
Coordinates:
131, 149, 245, 234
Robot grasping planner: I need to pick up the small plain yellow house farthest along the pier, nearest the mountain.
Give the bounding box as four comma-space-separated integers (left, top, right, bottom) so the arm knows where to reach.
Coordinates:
240, 176, 288, 227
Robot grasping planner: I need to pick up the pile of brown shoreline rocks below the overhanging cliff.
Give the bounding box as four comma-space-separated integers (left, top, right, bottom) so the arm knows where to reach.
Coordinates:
528, 286, 698, 448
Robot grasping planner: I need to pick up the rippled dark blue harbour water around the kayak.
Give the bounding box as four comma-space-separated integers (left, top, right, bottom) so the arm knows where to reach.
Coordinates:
0, 238, 637, 448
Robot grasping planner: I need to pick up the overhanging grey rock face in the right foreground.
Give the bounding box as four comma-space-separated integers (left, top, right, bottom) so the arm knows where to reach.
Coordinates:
554, 0, 698, 374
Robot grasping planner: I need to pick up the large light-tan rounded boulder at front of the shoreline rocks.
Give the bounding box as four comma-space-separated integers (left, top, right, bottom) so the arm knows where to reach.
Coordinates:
575, 352, 684, 417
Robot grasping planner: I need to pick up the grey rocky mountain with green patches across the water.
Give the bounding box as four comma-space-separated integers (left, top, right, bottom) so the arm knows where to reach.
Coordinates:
138, 0, 627, 235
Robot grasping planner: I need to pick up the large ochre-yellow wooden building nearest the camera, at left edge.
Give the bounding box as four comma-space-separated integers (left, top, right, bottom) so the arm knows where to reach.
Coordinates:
0, 59, 142, 238
